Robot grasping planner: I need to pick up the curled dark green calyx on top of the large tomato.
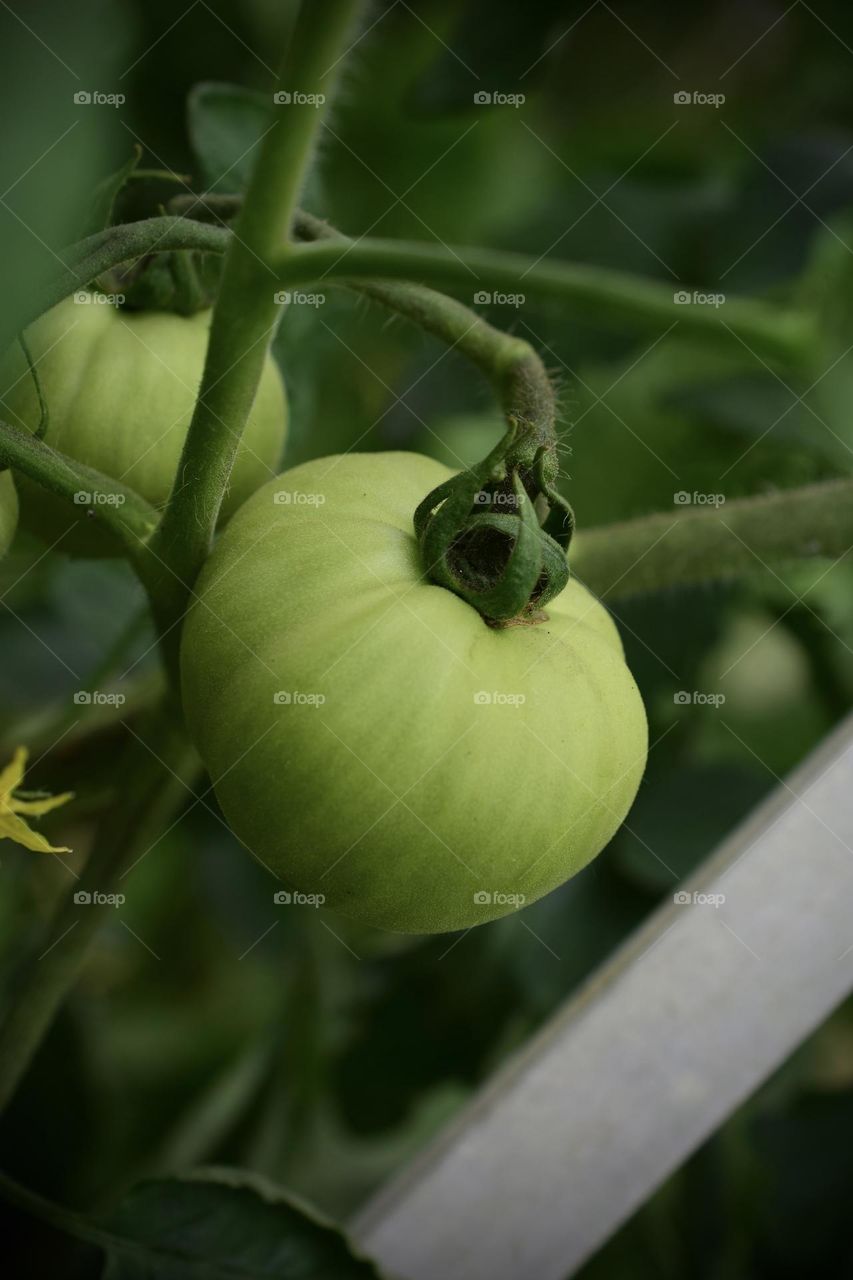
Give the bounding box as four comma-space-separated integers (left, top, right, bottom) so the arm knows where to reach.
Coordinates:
414, 419, 574, 626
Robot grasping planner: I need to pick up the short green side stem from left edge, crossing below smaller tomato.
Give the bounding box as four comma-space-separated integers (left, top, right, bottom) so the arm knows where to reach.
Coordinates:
0, 422, 158, 557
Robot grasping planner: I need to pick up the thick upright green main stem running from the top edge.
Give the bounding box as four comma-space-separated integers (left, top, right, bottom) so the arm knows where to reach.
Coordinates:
152, 0, 361, 630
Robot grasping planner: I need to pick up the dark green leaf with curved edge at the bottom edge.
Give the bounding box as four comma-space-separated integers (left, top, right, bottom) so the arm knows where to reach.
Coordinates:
100, 1169, 379, 1280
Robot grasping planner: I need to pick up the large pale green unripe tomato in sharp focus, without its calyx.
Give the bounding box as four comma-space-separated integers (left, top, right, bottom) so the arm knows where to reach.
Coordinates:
182, 453, 647, 933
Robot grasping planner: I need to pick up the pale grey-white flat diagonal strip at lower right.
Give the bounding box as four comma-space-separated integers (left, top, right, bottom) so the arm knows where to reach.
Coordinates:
351, 718, 853, 1280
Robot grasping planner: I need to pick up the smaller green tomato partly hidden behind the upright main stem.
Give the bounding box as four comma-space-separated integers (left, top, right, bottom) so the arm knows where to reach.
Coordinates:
0, 293, 287, 556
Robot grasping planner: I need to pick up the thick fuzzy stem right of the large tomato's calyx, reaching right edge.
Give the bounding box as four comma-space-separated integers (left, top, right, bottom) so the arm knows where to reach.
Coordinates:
573, 480, 853, 599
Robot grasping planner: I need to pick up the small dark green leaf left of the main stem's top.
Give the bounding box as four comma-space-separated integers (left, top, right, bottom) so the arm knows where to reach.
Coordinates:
187, 82, 273, 195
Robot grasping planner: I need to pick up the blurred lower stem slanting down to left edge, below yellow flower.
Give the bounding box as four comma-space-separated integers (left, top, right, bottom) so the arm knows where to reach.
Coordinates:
0, 705, 199, 1108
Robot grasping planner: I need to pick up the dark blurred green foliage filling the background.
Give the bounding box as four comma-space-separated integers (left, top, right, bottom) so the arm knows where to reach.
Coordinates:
0, 0, 853, 1280
